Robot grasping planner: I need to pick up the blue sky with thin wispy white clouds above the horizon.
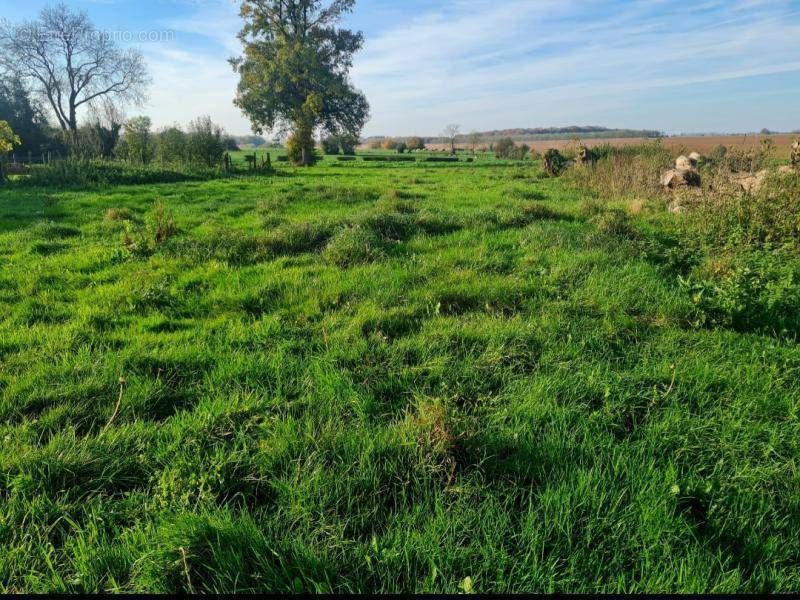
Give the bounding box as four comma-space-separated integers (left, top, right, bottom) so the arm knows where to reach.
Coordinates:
0, 0, 800, 135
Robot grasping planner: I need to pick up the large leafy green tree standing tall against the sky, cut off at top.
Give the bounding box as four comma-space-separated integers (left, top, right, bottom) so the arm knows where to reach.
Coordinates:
231, 0, 369, 165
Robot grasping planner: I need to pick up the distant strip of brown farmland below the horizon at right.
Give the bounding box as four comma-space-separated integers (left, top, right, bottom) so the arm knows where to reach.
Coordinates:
428, 134, 800, 158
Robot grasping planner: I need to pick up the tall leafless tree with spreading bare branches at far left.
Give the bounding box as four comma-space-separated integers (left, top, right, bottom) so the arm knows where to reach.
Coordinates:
0, 4, 150, 131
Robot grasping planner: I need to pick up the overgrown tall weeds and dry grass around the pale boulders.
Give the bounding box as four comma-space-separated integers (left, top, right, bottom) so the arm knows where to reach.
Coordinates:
567, 144, 800, 336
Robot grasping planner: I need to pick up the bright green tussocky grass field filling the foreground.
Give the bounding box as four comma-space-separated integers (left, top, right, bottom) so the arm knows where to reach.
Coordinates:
0, 160, 800, 592
